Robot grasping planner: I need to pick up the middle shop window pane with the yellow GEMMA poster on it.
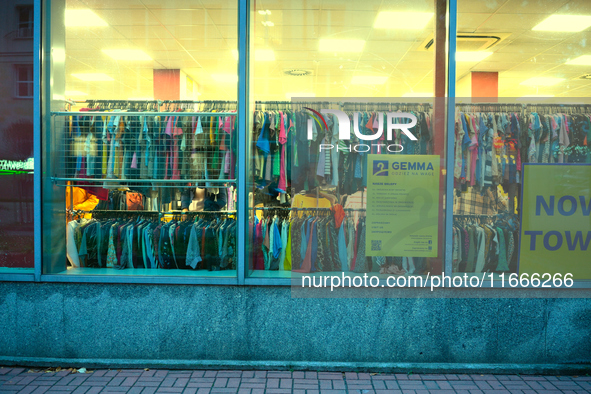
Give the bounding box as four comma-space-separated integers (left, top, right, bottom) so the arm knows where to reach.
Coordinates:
248, 0, 445, 278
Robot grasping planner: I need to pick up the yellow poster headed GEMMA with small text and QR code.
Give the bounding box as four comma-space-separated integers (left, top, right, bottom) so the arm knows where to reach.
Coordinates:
365, 155, 440, 257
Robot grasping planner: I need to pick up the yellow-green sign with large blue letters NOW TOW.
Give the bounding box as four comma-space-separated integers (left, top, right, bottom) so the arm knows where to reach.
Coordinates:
519, 164, 591, 279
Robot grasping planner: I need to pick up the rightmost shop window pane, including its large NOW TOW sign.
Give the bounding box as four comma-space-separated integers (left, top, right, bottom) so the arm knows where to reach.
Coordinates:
453, 0, 591, 287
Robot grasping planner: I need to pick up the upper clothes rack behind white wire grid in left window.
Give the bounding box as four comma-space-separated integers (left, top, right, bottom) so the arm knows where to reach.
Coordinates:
52, 101, 237, 187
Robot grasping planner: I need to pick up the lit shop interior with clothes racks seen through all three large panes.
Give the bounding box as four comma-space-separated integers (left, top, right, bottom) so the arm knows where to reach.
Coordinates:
56, 0, 591, 278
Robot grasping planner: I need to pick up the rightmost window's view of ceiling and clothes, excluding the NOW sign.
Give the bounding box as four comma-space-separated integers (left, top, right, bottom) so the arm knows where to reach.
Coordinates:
452, 0, 591, 274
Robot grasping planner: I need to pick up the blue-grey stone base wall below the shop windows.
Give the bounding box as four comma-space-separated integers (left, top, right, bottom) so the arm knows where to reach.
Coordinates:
0, 282, 591, 372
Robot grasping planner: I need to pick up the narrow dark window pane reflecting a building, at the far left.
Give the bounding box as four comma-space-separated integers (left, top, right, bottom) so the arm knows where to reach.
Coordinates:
0, 0, 35, 272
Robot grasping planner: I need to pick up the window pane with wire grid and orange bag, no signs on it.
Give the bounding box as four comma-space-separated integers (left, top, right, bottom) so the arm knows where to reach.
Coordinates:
44, 0, 240, 278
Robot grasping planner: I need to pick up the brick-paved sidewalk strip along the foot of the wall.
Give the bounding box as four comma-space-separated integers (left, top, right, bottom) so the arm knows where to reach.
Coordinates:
0, 368, 591, 394
